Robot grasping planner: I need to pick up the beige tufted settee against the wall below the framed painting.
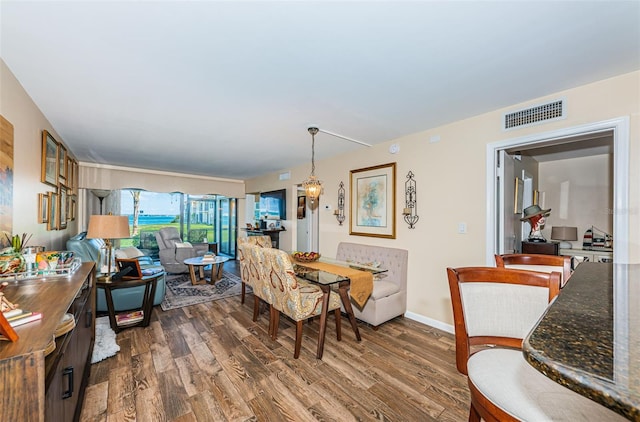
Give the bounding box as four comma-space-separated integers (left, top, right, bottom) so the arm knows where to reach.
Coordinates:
336, 242, 409, 329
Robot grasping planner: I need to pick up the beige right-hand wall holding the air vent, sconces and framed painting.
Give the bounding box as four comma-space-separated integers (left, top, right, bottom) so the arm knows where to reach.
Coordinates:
247, 72, 640, 332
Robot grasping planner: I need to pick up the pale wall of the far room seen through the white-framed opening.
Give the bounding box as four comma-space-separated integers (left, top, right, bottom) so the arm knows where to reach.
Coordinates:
540, 154, 613, 248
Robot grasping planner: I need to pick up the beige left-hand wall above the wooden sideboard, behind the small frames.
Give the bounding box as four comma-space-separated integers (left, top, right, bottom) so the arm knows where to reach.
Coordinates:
0, 60, 77, 250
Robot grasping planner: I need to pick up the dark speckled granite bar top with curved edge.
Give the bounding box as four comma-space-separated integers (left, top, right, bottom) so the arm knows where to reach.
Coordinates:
523, 262, 640, 421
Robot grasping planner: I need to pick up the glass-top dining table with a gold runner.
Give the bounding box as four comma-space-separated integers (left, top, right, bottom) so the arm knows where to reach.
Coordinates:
293, 256, 388, 359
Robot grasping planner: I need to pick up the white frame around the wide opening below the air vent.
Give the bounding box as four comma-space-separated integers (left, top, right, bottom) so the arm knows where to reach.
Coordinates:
485, 116, 629, 266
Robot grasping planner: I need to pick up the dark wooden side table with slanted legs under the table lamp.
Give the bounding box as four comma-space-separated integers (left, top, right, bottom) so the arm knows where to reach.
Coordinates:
96, 271, 164, 333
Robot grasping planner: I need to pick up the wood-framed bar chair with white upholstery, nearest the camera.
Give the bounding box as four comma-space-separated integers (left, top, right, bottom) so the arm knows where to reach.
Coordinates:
447, 267, 624, 421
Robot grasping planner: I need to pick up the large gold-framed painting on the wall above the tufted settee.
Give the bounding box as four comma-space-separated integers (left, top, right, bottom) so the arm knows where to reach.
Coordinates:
349, 163, 396, 239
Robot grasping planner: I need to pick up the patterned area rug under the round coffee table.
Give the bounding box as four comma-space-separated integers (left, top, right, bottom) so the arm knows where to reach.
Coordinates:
160, 271, 249, 311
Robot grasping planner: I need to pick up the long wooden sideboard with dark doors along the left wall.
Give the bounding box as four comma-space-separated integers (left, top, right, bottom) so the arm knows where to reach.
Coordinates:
0, 262, 96, 421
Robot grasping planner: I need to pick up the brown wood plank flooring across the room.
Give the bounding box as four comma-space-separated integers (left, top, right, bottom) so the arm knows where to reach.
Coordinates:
80, 262, 469, 422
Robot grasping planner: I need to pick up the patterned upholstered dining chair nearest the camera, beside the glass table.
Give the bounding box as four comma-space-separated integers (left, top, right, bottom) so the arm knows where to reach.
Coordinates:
255, 248, 341, 359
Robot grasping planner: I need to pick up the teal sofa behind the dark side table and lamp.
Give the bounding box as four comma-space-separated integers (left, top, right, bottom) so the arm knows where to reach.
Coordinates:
67, 232, 166, 312
